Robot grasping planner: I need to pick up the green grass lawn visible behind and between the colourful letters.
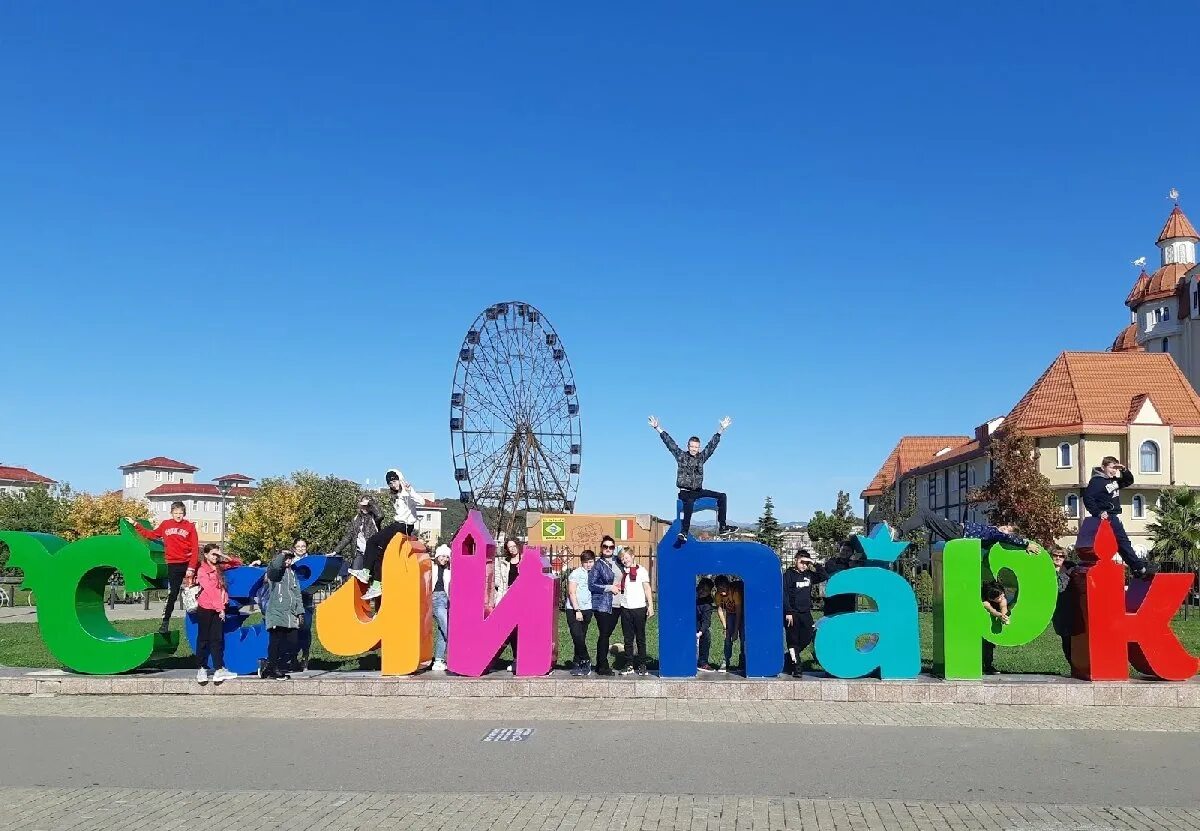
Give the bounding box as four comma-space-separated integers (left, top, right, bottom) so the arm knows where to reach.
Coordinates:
0, 612, 1200, 675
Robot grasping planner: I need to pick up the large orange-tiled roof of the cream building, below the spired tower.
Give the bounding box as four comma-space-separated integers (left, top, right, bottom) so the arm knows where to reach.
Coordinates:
1004, 352, 1200, 436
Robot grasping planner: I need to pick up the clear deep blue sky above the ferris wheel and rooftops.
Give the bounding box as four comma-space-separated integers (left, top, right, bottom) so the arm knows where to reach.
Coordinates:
0, 2, 1200, 519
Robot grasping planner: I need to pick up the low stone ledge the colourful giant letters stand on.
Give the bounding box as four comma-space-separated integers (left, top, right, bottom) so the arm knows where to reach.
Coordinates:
0, 668, 1200, 707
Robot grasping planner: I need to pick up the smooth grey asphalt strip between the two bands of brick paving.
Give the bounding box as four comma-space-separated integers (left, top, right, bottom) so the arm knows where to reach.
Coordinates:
7, 715, 1200, 807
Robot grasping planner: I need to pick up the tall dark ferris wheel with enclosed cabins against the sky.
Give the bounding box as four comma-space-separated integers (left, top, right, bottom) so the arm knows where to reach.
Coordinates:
450, 300, 582, 536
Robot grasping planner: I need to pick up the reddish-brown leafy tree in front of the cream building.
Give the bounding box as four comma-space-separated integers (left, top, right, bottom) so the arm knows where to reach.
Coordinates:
967, 430, 1067, 545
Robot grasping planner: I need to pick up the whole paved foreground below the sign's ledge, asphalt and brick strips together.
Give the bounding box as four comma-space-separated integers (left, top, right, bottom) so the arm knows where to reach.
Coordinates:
0, 695, 1200, 831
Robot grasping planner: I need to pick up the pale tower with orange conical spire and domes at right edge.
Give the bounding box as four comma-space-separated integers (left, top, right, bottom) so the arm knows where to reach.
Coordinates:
1111, 191, 1200, 389
